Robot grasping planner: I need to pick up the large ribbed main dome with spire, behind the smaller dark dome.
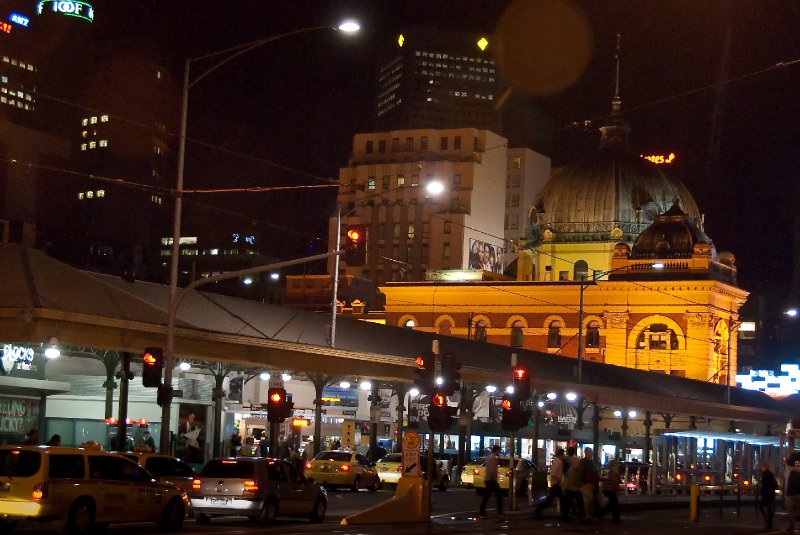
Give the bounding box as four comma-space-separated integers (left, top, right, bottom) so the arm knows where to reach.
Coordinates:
534, 103, 700, 243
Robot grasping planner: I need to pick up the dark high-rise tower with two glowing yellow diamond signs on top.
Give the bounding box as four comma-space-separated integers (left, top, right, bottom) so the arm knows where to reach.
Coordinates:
375, 27, 500, 133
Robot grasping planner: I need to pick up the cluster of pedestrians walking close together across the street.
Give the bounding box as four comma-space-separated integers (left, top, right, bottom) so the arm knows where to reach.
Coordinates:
534, 446, 622, 524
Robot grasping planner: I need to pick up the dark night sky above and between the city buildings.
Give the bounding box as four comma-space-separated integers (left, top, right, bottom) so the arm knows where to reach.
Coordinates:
9, 0, 800, 356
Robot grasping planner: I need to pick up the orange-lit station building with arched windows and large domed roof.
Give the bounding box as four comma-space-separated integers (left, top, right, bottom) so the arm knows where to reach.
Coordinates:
380, 99, 748, 384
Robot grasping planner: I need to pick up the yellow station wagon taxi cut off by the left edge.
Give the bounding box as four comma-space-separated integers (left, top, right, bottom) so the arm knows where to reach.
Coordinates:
0, 446, 188, 533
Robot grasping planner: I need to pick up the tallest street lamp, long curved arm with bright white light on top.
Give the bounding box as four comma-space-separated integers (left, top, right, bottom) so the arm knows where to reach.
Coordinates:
160, 21, 359, 453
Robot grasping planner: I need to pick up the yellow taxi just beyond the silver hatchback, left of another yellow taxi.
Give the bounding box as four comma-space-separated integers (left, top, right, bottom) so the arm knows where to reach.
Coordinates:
305, 450, 381, 492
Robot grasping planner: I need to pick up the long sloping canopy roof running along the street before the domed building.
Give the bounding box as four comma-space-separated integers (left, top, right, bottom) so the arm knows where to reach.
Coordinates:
0, 245, 791, 424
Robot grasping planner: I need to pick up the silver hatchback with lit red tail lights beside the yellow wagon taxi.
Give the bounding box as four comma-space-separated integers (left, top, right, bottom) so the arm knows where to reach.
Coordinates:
189, 457, 328, 524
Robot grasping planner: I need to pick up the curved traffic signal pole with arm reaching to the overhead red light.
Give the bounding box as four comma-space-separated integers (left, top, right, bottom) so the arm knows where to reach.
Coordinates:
159, 250, 342, 453
